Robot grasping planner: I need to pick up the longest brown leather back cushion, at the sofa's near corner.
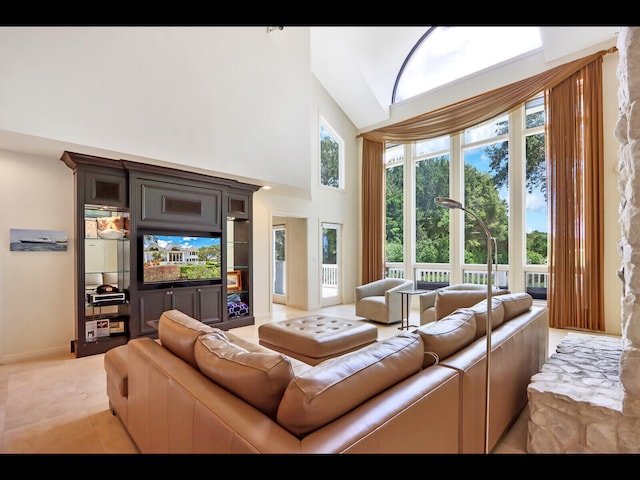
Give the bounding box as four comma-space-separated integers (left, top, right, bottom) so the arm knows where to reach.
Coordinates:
277, 332, 424, 438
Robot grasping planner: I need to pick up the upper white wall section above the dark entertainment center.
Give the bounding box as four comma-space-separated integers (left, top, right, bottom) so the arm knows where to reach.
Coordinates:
0, 26, 312, 190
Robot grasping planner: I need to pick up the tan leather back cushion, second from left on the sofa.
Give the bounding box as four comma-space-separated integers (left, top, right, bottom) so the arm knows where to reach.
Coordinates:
194, 331, 293, 420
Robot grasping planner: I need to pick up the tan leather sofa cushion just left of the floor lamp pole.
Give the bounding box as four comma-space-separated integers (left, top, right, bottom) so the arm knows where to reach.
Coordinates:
417, 308, 476, 368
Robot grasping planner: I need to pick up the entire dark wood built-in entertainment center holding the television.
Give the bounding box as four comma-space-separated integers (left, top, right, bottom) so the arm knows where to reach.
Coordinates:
61, 152, 260, 357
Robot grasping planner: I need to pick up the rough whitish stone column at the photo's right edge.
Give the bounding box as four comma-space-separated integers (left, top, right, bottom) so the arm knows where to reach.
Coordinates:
615, 27, 640, 416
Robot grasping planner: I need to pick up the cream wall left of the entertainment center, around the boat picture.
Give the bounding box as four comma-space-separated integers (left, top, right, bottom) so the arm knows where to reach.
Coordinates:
0, 150, 75, 363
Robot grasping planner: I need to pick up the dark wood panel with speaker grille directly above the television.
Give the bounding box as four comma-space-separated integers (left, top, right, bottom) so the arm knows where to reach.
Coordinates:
135, 179, 222, 230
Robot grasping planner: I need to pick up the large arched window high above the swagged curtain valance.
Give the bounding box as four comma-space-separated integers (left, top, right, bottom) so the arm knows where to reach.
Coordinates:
392, 26, 542, 103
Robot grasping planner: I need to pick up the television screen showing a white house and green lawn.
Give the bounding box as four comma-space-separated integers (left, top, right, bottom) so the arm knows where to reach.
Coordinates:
142, 234, 222, 285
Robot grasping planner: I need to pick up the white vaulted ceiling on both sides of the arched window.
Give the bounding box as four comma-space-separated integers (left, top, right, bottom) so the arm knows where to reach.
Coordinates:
310, 26, 619, 129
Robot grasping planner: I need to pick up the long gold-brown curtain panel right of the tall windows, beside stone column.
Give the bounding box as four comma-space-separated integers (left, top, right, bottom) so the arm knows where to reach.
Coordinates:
545, 58, 605, 331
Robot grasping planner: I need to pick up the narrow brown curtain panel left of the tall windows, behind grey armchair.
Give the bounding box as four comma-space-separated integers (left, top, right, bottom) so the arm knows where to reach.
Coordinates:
362, 139, 385, 284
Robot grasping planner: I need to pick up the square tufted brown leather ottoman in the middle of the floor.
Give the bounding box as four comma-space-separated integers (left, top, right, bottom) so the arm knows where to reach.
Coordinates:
258, 315, 378, 365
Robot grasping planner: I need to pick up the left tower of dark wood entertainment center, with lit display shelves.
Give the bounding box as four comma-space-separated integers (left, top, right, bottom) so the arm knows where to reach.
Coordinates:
62, 152, 130, 357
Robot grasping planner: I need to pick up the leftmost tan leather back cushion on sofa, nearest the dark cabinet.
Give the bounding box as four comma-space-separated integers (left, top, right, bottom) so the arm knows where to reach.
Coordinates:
158, 310, 219, 368
